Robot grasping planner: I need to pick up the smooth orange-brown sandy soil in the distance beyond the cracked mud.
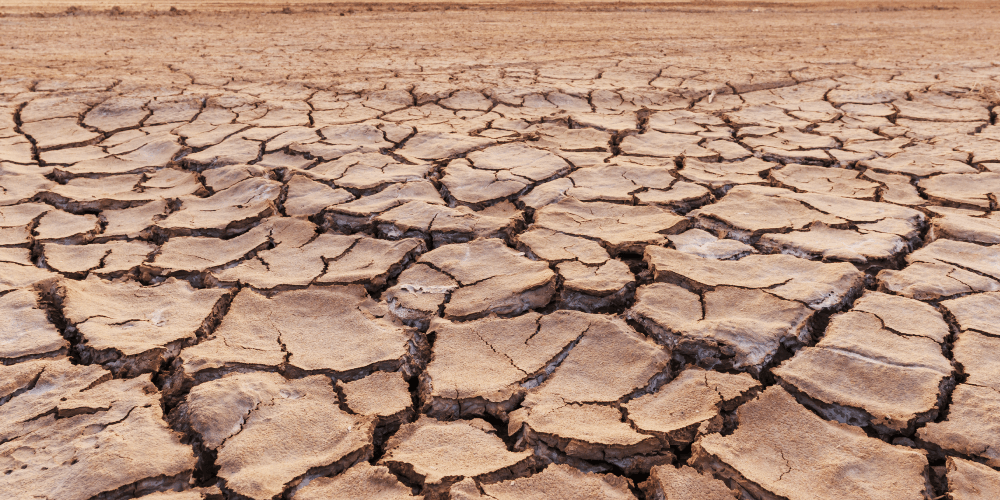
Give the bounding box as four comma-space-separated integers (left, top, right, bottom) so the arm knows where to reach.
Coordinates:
0, 2, 998, 83
